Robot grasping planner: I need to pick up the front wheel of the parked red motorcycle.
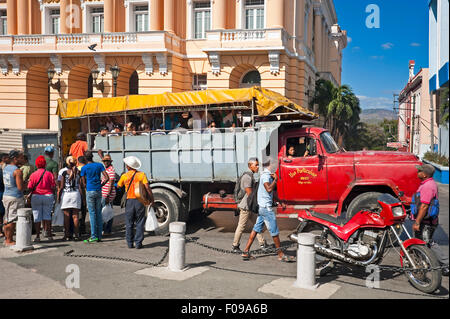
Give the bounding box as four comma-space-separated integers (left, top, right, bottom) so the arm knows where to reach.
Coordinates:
403, 245, 442, 294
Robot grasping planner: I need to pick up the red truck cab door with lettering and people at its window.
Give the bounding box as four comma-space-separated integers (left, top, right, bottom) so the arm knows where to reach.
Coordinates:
279, 135, 328, 203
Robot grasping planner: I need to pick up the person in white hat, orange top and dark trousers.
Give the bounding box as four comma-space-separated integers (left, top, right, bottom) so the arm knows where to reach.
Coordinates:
117, 156, 153, 249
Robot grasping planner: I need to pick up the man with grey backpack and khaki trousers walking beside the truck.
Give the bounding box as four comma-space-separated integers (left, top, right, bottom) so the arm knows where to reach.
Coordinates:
232, 157, 267, 252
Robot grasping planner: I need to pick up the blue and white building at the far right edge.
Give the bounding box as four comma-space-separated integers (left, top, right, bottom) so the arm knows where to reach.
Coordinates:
428, 0, 449, 157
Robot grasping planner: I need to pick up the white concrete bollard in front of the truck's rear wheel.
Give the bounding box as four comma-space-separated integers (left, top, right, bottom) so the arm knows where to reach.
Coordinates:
169, 222, 186, 271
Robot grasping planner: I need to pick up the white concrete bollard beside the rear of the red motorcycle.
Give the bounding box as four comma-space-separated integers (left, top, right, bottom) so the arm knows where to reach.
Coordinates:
294, 233, 318, 290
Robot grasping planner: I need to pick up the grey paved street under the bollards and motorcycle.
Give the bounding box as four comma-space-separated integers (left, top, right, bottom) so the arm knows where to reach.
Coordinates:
0, 185, 449, 299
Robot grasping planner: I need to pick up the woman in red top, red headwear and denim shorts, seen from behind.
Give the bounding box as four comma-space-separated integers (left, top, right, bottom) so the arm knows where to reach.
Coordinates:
28, 156, 56, 242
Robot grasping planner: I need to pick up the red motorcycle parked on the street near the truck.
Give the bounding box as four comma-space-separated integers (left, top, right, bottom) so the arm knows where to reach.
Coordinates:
289, 194, 442, 293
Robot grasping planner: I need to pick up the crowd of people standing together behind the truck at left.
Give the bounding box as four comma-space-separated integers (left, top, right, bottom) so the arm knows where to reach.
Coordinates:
0, 133, 153, 249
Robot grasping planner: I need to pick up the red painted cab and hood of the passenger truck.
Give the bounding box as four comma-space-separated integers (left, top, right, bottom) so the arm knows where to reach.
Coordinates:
203, 126, 421, 224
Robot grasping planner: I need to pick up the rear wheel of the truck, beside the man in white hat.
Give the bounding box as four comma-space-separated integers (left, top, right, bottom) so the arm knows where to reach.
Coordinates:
152, 188, 182, 235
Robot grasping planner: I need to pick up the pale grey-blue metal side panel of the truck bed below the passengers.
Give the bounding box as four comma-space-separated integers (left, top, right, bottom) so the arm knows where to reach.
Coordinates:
94, 122, 280, 183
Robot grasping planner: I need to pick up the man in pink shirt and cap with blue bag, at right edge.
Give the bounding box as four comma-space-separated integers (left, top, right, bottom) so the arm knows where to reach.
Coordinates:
411, 164, 448, 276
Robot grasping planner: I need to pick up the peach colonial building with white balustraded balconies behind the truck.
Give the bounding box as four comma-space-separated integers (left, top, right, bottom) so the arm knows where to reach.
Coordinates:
0, 0, 347, 131
